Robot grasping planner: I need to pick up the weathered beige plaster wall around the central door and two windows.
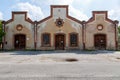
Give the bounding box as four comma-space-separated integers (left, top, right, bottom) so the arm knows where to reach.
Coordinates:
37, 18, 83, 49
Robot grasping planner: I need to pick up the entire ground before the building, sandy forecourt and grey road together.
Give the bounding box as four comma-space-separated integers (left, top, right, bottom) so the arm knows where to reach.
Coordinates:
0, 50, 120, 80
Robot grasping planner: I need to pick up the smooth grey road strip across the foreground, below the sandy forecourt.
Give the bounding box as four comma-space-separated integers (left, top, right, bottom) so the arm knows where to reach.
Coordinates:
0, 62, 120, 80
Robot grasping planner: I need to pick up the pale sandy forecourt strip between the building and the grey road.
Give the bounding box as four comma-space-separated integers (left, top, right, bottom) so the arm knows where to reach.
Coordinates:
0, 50, 120, 64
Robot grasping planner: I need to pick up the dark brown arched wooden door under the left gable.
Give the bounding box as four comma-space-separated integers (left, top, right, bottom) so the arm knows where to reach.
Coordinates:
14, 34, 26, 49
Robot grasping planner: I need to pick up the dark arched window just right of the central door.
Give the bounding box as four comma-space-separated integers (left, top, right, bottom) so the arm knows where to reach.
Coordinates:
70, 33, 78, 47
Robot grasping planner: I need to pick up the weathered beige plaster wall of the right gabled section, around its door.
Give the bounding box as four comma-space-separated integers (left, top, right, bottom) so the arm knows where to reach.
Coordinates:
85, 14, 115, 49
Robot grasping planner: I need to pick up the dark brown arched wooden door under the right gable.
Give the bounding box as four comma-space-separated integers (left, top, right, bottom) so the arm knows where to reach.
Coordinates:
94, 34, 106, 49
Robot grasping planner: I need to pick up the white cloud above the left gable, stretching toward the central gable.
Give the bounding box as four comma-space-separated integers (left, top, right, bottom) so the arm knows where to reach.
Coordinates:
14, 2, 44, 20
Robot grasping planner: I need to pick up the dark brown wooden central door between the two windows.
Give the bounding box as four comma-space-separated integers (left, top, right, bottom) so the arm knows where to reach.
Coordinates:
55, 34, 65, 50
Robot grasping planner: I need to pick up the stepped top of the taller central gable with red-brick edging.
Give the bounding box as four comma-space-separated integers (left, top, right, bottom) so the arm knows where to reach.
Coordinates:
38, 5, 82, 24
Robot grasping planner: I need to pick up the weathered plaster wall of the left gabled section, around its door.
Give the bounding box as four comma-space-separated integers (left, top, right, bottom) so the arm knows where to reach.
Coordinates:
4, 14, 34, 49
